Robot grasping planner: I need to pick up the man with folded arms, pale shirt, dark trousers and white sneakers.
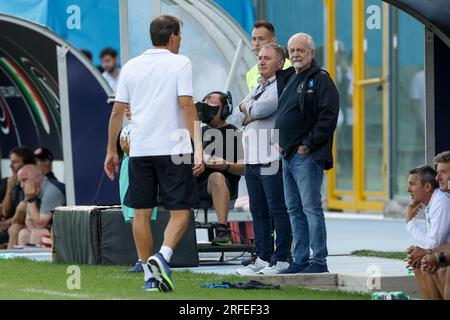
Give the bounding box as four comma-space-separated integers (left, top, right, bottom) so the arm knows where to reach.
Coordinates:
236, 44, 292, 275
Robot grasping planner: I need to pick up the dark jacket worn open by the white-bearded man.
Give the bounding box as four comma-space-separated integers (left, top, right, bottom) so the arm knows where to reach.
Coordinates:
277, 60, 339, 170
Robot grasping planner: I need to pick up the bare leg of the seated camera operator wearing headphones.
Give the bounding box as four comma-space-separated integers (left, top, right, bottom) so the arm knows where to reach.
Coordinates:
207, 172, 230, 225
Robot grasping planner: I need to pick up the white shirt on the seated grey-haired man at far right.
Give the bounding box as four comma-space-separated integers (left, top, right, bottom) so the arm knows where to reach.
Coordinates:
406, 189, 450, 249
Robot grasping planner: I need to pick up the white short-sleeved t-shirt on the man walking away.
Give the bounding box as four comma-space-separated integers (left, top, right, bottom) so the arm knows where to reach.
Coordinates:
116, 49, 193, 157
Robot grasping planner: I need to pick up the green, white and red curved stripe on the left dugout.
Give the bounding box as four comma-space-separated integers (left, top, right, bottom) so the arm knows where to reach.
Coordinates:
0, 57, 50, 134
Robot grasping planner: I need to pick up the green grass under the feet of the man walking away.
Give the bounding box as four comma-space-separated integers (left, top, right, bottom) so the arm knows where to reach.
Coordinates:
0, 259, 370, 300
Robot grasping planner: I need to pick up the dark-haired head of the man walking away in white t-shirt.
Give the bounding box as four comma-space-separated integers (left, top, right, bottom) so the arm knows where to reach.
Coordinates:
150, 15, 182, 47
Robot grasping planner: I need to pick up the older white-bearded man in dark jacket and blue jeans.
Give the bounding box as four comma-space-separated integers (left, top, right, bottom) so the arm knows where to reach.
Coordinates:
275, 33, 339, 273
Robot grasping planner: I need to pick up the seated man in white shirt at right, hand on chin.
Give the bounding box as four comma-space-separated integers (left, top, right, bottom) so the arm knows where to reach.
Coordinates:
406, 166, 450, 299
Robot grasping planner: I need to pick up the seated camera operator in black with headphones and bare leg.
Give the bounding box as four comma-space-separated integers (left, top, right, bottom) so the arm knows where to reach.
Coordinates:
194, 91, 244, 245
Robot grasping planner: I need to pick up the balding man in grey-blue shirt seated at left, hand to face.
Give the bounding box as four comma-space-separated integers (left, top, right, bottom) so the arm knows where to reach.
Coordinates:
17, 165, 66, 245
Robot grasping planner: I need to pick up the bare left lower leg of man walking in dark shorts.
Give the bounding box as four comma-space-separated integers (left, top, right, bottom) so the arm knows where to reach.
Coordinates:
132, 209, 153, 263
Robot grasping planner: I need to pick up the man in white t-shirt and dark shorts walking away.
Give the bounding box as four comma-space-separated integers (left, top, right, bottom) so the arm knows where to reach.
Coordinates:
105, 16, 204, 291
